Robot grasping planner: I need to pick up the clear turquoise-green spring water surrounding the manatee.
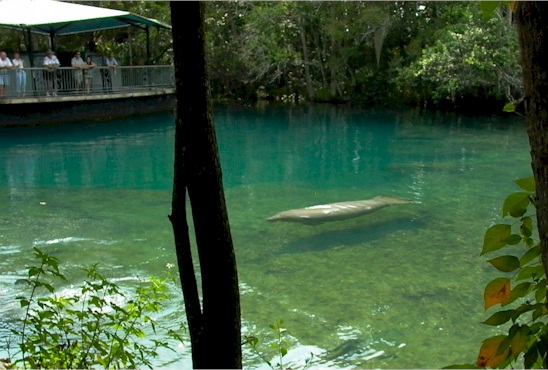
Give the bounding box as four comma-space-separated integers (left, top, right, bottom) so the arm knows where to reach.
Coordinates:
0, 107, 531, 369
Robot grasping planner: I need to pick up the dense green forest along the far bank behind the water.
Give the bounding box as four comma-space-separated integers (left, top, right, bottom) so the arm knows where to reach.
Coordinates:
0, 1, 524, 114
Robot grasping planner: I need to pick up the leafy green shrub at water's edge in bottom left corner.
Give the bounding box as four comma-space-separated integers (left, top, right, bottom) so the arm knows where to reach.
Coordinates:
8, 248, 182, 369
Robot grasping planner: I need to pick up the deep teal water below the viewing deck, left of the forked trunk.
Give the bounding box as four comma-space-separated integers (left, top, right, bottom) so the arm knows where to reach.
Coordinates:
0, 115, 173, 188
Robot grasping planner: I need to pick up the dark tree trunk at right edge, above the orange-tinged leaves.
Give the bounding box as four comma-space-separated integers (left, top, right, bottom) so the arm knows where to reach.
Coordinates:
516, 1, 548, 276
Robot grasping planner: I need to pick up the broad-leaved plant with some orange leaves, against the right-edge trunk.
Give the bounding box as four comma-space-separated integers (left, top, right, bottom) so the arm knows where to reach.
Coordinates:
448, 178, 548, 369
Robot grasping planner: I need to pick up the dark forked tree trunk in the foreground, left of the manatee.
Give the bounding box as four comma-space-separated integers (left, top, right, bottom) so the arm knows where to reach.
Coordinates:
169, 1, 242, 369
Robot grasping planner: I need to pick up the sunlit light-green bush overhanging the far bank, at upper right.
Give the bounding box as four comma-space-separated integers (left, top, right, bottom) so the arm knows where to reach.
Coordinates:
396, 3, 523, 104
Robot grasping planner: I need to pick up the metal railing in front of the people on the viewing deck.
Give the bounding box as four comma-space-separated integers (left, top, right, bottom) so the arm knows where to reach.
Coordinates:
0, 65, 175, 98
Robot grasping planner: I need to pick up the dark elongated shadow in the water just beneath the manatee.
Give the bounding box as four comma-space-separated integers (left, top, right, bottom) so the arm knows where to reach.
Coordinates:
280, 216, 426, 253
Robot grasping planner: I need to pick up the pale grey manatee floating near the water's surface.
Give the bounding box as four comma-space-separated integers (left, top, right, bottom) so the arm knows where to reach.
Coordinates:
267, 196, 413, 225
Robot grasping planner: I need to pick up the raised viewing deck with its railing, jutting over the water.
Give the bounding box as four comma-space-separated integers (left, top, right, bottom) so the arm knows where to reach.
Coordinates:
0, 66, 175, 127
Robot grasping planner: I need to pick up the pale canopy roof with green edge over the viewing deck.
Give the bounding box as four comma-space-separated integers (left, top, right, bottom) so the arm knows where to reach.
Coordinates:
0, 0, 171, 36
